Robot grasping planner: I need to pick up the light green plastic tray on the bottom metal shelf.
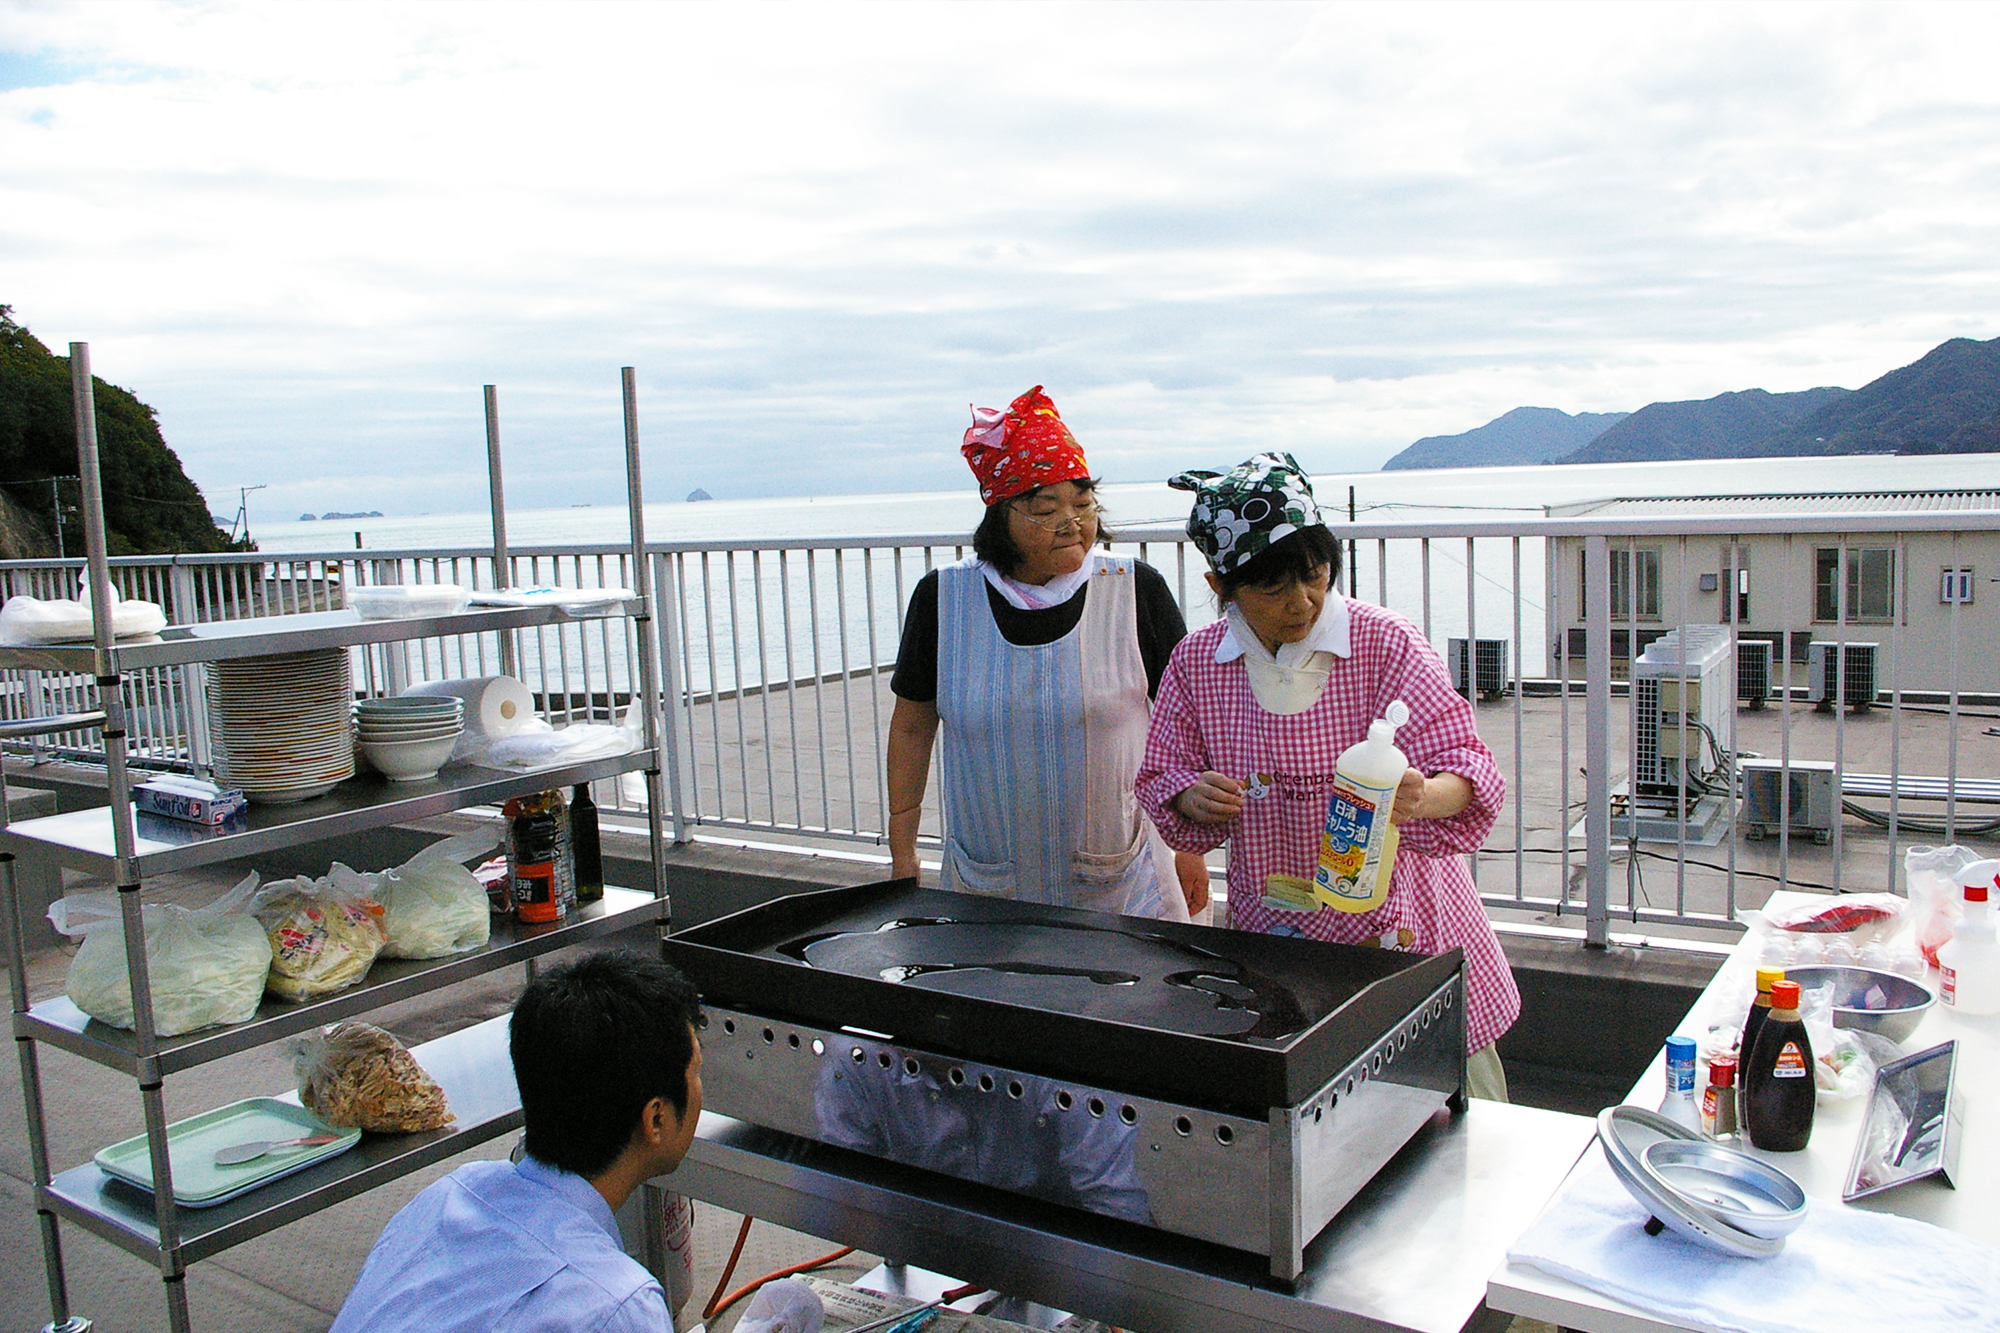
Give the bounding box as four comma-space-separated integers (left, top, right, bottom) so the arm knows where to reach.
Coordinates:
96, 1097, 362, 1209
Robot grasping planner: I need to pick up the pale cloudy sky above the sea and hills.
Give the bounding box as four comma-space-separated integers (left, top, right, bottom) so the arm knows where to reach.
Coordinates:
0, 2, 2000, 516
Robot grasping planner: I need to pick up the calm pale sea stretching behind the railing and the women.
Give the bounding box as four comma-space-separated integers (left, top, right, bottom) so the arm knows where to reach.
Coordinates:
254, 454, 2000, 688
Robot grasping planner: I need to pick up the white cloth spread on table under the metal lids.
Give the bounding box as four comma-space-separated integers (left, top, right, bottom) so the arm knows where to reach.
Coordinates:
1508, 1145, 2000, 1333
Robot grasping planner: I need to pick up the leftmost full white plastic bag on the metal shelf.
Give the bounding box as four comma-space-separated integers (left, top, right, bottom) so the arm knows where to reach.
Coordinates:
48, 875, 270, 1037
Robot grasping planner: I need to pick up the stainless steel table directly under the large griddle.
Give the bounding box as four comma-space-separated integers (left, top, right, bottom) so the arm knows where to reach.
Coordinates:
672, 1101, 1594, 1333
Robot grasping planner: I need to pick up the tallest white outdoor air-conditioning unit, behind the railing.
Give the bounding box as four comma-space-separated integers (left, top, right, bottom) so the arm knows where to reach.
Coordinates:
1632, 624, 1732, 795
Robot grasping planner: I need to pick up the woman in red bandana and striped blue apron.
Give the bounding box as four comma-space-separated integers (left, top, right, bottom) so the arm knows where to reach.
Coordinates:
888, 384, 1208, 921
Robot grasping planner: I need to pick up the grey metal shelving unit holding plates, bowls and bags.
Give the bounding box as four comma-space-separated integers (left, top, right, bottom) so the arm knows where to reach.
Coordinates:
0, 342, 670, 1333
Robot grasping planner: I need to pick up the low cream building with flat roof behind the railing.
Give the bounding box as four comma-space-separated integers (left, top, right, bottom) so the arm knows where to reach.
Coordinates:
1544, 488, 2000, 695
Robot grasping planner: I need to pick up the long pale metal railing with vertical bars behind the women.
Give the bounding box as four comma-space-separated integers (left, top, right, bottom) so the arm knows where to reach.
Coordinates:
0, 500, 2000, 945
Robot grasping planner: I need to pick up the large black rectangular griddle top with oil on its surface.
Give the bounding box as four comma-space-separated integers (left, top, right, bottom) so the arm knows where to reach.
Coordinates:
664, 879, 1462, 1119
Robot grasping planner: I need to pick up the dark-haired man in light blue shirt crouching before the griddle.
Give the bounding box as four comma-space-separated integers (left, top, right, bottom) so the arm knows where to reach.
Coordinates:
334, 953, 702, 1333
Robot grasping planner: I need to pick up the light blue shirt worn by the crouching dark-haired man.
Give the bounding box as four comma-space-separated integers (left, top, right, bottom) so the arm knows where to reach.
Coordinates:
332, 1157, 674, 1333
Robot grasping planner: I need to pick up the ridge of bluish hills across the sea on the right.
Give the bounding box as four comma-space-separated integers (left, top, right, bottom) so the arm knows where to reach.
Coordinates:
1382, 338, 2000, 472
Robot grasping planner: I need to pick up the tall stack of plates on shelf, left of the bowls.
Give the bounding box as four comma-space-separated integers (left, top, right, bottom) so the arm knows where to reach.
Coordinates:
208, 648, 354, 805
